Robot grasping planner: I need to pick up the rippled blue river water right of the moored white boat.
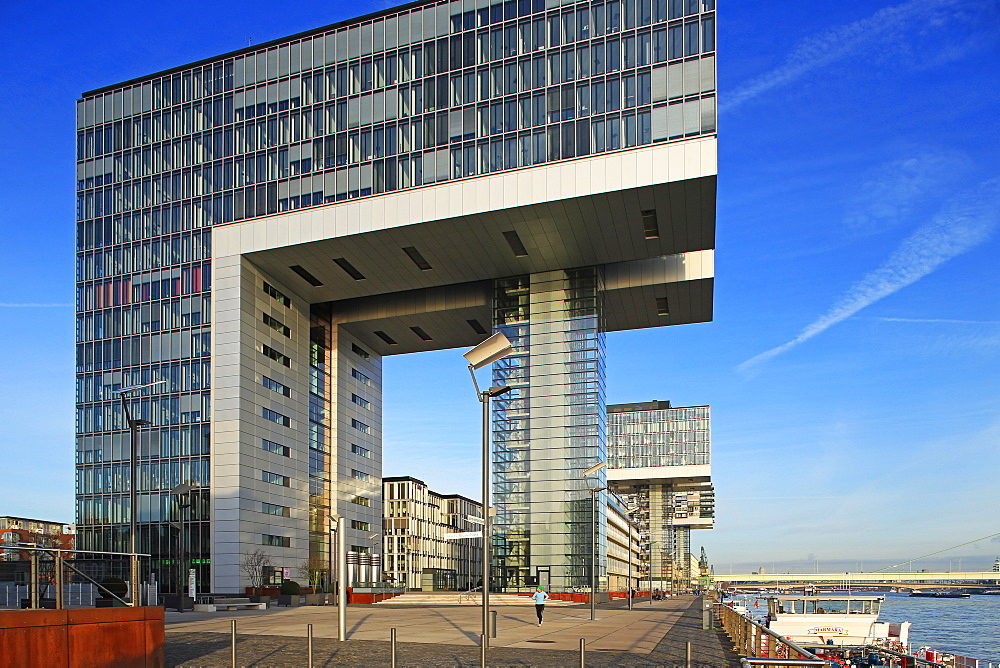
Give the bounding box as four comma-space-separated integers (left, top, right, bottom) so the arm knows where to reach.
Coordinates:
879, 594, 1000, 663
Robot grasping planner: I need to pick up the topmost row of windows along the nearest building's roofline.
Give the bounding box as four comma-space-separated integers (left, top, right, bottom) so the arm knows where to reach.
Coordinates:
77, 0, 714, 127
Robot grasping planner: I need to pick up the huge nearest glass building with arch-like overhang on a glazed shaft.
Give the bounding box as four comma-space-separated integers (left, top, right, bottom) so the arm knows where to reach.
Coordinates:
76, 0, 716, 591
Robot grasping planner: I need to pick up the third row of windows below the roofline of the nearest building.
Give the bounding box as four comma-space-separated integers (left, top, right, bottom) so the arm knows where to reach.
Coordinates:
78, 51, 715, 196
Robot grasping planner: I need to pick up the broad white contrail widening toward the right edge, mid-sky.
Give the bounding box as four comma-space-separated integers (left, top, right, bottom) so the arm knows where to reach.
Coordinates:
737, 179, 1000, 371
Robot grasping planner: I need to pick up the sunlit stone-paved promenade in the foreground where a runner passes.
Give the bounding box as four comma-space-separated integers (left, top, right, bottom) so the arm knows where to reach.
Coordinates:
166, 596, 739, 667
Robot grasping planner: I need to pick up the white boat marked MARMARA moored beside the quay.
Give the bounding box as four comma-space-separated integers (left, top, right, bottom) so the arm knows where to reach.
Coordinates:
767, 595, 910, 648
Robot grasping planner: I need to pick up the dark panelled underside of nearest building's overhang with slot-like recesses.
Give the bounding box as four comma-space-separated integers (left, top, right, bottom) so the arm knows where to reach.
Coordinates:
247, 176, 716, 304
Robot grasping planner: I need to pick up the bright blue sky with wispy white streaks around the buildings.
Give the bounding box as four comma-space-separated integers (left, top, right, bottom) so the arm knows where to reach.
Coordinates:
0, 0, 1000, 571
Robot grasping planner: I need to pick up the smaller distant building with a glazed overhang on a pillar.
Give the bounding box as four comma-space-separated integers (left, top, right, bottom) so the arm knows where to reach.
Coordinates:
608, 401, 715, 588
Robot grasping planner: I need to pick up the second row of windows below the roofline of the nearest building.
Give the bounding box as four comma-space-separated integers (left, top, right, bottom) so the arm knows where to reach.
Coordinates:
77, 26, 715, 165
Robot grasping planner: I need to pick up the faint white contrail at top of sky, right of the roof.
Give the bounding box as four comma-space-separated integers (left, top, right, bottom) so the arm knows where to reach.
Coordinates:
719, 0, 956, 112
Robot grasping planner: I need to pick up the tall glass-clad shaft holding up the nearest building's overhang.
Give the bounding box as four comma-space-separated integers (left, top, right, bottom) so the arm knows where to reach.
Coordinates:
493, 267, 606, 591
